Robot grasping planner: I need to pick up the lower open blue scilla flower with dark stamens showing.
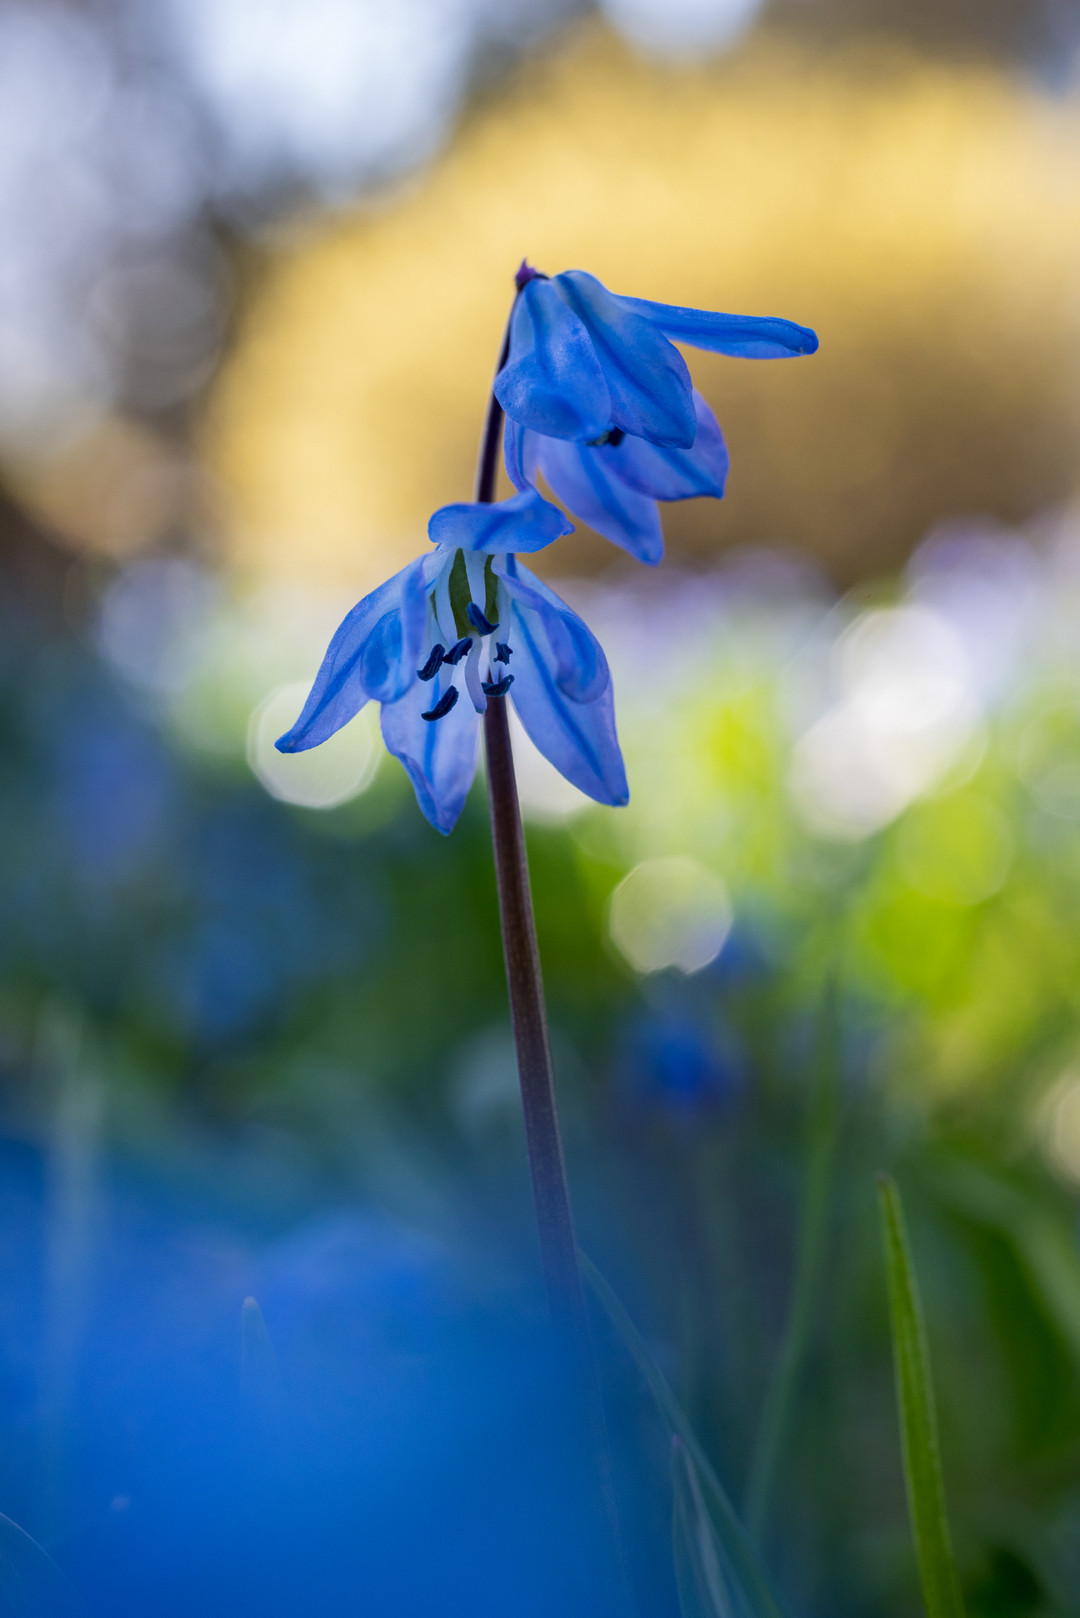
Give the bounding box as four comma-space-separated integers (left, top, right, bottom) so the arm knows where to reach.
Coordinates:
277, 490, 630, 832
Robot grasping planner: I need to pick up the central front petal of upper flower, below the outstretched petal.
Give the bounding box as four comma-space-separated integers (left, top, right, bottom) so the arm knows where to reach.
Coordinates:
553, 270, 695, 448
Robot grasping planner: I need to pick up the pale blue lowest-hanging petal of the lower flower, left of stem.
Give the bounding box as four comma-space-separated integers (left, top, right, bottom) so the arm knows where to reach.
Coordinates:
381, 671, 479, 835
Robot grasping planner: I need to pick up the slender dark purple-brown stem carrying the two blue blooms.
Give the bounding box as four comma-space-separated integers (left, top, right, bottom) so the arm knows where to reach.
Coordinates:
476, 328, 588, 1356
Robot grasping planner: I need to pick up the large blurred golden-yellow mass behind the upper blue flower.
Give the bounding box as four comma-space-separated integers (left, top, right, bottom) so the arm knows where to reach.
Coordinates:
202, 24, 1080, 589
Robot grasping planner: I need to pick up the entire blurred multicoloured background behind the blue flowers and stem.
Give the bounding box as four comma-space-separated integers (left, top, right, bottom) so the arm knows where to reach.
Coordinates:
0, 0, 1080, 1618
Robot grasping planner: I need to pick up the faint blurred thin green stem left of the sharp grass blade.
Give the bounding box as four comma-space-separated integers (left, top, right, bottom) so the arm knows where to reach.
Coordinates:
745, 979, 839, 1545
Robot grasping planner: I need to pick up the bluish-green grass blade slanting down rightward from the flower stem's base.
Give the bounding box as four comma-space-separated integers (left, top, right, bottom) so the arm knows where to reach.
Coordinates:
580, 1254, 784, 1618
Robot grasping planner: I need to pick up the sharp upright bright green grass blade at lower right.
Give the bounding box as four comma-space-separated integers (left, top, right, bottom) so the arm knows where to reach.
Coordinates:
878, 1175, 963, 1618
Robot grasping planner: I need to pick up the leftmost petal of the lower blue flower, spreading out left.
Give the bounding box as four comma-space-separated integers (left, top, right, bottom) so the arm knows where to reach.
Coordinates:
275, 557, 427, 752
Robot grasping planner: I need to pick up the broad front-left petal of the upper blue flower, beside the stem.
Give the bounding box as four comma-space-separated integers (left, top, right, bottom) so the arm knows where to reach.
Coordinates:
495, 278, 612, 438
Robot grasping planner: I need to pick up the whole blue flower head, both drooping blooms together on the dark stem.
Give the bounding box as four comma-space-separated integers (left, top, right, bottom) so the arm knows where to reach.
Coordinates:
277, 264, 818, 832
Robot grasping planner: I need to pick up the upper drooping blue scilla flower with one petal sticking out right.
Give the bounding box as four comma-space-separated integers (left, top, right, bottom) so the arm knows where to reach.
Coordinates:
495, 264, 818, 563
